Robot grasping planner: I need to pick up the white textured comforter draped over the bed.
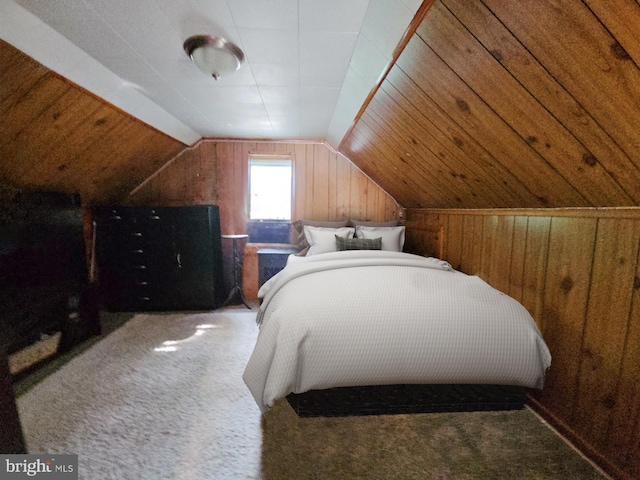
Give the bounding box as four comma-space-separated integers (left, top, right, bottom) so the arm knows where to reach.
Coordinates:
243, 250, 551, 412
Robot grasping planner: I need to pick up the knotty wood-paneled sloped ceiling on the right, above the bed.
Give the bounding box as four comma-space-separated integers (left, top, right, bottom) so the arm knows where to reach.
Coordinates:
340, 0, 640, 208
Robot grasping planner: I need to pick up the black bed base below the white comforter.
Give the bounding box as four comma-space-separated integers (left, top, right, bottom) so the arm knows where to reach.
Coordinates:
287, 385, 528, 417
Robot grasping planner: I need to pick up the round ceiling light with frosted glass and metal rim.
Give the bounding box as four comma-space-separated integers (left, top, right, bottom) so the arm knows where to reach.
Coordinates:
182, 35, 244, 80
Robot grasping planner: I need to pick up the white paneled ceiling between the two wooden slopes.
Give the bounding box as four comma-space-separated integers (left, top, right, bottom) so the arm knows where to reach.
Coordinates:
0, 0, 421, 147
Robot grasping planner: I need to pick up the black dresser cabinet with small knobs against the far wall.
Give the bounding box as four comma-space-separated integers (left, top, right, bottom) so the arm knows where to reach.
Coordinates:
95, 206, 224, 311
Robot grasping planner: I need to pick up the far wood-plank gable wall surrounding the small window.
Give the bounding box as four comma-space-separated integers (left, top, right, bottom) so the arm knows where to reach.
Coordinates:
127, 140, 400, 233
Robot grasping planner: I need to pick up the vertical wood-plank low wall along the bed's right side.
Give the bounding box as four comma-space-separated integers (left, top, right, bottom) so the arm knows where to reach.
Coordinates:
406, 208, 640, 479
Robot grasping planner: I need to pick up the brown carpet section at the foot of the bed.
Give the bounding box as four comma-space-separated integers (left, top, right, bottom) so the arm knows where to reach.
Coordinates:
262, 401, 606, 480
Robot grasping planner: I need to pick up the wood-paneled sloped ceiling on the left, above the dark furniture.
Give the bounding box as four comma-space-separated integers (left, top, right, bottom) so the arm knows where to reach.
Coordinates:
0, 40, 186, 202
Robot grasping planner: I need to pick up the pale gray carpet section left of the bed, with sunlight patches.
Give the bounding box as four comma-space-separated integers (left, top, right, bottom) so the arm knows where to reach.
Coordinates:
18, 310, 261, 480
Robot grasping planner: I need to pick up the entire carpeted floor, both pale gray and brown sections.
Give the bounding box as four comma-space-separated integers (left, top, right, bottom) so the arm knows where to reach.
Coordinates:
13, 309, 605, 480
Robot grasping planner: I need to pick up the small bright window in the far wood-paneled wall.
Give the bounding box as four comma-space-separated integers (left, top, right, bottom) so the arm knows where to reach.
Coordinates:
249, 155, 293, 222
